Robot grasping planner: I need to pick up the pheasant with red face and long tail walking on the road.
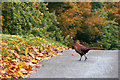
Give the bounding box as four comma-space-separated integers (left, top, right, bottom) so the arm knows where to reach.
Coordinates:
72, 37, 102, 61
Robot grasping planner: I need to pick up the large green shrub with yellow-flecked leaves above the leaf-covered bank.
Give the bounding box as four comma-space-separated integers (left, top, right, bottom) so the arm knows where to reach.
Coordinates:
2, 2, 69, 43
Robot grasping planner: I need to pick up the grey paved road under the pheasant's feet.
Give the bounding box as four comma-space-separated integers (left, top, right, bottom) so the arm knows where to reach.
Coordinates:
30, 50, 118, 78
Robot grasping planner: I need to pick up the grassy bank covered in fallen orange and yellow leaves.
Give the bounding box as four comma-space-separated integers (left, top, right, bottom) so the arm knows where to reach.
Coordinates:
0, 35, 67, 78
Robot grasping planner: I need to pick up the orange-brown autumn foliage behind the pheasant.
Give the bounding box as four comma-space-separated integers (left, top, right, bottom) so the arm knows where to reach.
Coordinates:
48, 2, 120, 49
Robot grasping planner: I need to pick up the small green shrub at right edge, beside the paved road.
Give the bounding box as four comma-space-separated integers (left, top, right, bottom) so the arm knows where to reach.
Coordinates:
101, 21, 120, 49
